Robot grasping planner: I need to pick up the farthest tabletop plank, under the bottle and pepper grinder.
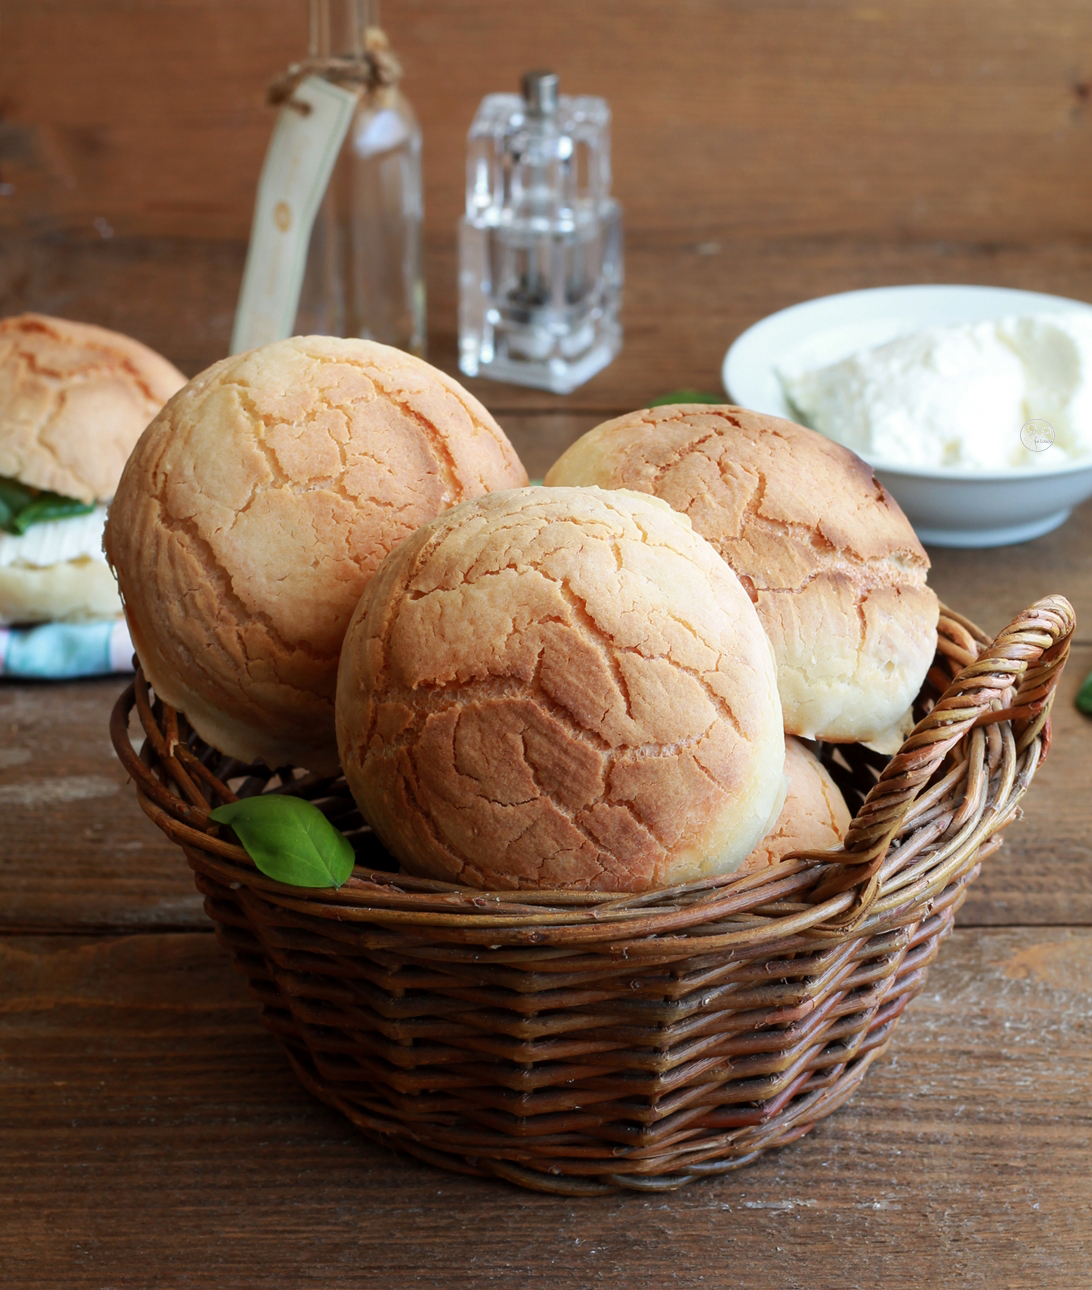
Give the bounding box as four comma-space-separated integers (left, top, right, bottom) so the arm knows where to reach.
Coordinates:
0, 232, 1092, 421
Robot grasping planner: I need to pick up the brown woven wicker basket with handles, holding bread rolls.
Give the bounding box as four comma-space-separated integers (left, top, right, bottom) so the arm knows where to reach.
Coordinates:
111, 597, 1074, 1196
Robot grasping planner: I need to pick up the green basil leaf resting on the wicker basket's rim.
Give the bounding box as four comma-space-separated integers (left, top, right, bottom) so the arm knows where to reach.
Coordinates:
209, 793, 353, 888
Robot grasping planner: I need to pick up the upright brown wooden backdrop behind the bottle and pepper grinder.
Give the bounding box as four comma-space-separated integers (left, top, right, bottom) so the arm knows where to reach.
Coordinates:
3, 0, 1092, 243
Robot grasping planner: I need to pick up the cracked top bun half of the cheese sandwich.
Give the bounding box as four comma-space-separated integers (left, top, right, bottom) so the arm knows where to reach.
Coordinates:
0, 313, 186, 503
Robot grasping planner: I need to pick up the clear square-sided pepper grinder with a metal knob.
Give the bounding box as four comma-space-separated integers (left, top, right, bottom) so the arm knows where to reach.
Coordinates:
459, 72, 623, 393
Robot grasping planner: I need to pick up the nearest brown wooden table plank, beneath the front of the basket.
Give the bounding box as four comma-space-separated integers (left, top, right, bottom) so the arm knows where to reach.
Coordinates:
0, 929, 1092, 1290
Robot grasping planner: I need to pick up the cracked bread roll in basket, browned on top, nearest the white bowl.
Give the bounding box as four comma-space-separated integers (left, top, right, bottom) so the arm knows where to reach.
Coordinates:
545, 404, 939, 742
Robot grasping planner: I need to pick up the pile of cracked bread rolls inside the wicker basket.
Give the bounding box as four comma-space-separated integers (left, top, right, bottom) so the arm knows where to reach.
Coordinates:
106, 337, 937, 891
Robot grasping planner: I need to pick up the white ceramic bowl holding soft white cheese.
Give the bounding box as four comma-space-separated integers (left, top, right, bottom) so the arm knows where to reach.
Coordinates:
722, 285, 1092, 547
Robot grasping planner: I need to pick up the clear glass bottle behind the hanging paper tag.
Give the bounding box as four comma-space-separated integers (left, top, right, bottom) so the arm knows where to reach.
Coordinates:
295, 0, 425, 355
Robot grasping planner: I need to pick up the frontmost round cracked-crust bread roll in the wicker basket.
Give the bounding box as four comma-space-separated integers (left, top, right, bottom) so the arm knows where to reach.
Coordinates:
338, 488, 785, 891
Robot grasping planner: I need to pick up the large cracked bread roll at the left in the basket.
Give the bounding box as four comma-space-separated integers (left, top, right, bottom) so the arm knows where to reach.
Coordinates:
106, 337, 527, 773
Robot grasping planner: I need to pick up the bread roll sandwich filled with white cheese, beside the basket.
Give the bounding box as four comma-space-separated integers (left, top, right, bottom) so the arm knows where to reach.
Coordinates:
0, 313, 186, 626
